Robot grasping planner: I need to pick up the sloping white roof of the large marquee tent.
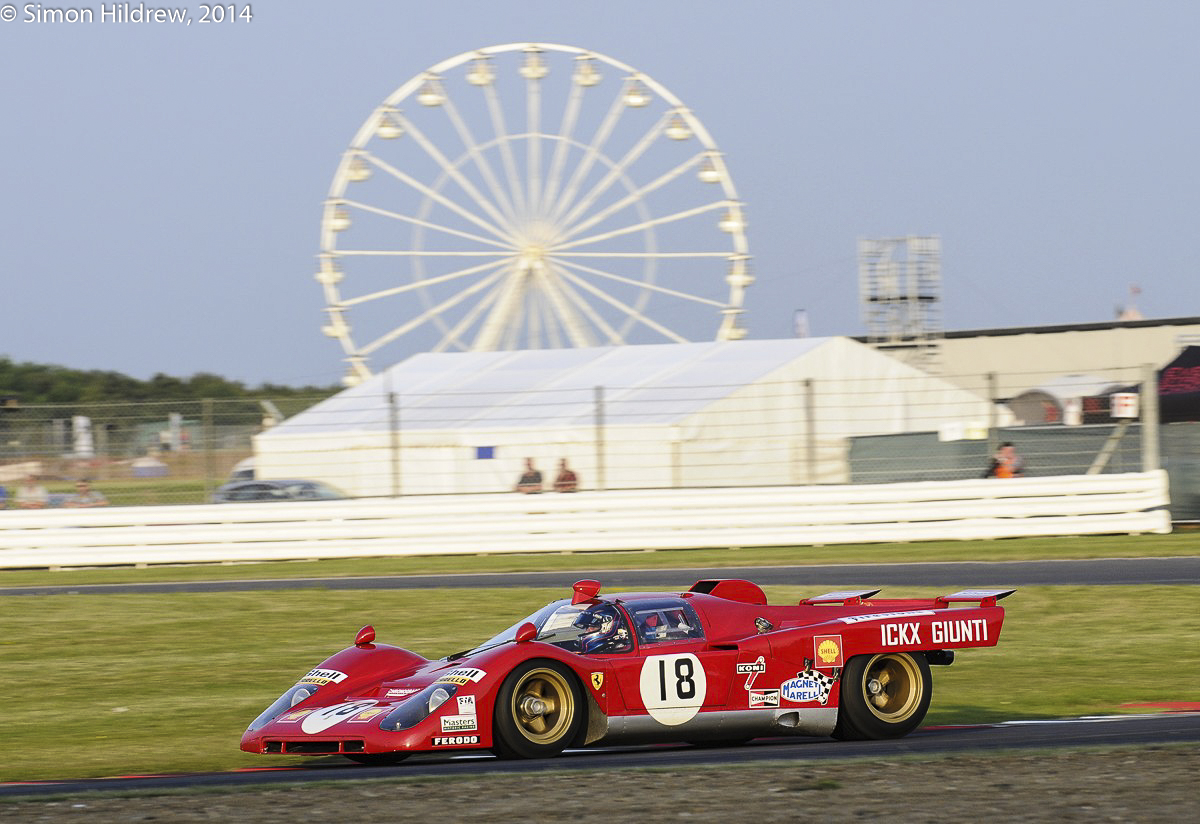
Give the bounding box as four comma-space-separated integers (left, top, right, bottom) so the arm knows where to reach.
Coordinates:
271, 338, 835, 437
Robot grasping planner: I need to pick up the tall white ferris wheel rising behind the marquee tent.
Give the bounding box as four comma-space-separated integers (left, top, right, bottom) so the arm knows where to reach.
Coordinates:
317, 43, 754, 385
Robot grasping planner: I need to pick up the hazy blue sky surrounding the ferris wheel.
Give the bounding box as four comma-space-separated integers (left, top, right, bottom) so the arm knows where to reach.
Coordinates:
0, 0, 1200, 385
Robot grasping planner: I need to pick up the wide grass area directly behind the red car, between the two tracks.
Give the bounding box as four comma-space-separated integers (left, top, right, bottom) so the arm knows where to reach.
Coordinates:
0, 587, 1200, 781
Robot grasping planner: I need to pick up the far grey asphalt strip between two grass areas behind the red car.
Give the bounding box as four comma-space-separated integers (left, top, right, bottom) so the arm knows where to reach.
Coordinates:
0, 555, 1200, 595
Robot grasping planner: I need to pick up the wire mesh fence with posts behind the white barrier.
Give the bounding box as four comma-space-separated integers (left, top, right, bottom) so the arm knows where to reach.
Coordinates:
0, 368, 1200, 517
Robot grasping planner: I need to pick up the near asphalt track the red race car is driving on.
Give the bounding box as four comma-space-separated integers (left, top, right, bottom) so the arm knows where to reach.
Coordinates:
0, 712, 1200, 798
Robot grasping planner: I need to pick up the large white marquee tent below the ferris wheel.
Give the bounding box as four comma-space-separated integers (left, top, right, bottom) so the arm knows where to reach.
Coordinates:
254, 337, 990, 495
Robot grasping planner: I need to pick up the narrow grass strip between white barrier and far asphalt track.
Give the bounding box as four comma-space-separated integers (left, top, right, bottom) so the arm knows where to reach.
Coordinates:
0, 531, 1200, 587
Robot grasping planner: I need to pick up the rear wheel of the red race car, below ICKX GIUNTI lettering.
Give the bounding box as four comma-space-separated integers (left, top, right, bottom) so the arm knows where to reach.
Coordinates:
833, 652, 934, 740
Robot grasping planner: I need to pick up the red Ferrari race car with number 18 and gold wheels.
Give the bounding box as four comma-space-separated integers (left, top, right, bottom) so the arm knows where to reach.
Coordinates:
241, 579, 1014, 764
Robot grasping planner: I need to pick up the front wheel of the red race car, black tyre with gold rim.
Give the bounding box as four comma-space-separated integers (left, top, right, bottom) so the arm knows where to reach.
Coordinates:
492, 660, 587, 758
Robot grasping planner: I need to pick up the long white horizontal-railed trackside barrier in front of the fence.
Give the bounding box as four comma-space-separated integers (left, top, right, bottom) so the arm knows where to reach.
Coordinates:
0, 470, 1171, 569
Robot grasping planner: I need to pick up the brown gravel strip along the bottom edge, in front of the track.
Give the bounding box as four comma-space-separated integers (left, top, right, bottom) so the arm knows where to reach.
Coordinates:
7, 746, 1200, 824
